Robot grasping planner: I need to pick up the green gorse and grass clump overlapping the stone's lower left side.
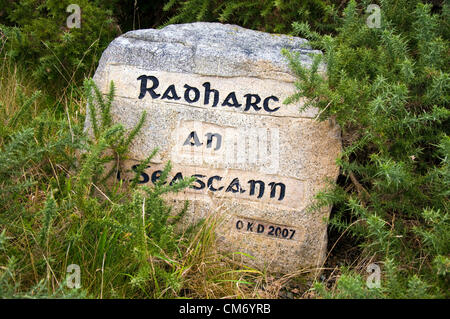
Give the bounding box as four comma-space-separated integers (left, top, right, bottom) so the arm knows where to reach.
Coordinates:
0, 74, 198, 298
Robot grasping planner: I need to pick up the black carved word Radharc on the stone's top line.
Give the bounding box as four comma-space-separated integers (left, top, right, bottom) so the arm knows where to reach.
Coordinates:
137, 75, 280, 113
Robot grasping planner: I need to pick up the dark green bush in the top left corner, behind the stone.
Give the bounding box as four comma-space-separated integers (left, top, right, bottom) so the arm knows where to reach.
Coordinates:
0, 0, 119, 90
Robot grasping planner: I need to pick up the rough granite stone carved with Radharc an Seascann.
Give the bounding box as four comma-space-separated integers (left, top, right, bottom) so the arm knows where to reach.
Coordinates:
86, 23, 341, 272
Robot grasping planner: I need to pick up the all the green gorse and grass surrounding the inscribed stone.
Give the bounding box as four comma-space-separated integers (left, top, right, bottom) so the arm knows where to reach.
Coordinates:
0, 0, 450, 298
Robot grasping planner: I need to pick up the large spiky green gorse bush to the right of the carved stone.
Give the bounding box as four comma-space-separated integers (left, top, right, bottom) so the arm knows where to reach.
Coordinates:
285, 1, 450, 298
